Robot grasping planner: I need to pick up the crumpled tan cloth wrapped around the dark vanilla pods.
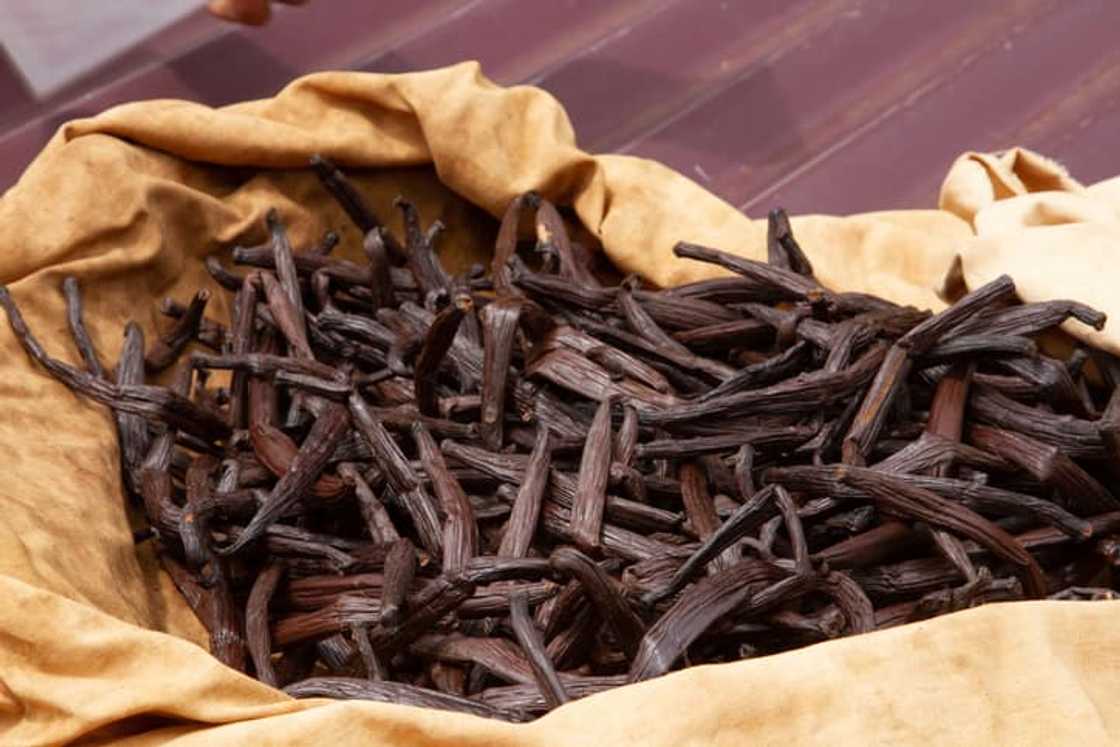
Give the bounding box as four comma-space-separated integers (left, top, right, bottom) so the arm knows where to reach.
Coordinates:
0, 64, 1120, 747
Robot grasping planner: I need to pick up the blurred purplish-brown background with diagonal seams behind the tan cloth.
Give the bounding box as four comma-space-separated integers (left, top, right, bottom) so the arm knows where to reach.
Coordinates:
0, 0, 1120, 214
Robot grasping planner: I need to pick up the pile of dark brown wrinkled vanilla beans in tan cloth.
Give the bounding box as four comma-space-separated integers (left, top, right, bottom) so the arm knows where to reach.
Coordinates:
0, 158, 1120, 720
